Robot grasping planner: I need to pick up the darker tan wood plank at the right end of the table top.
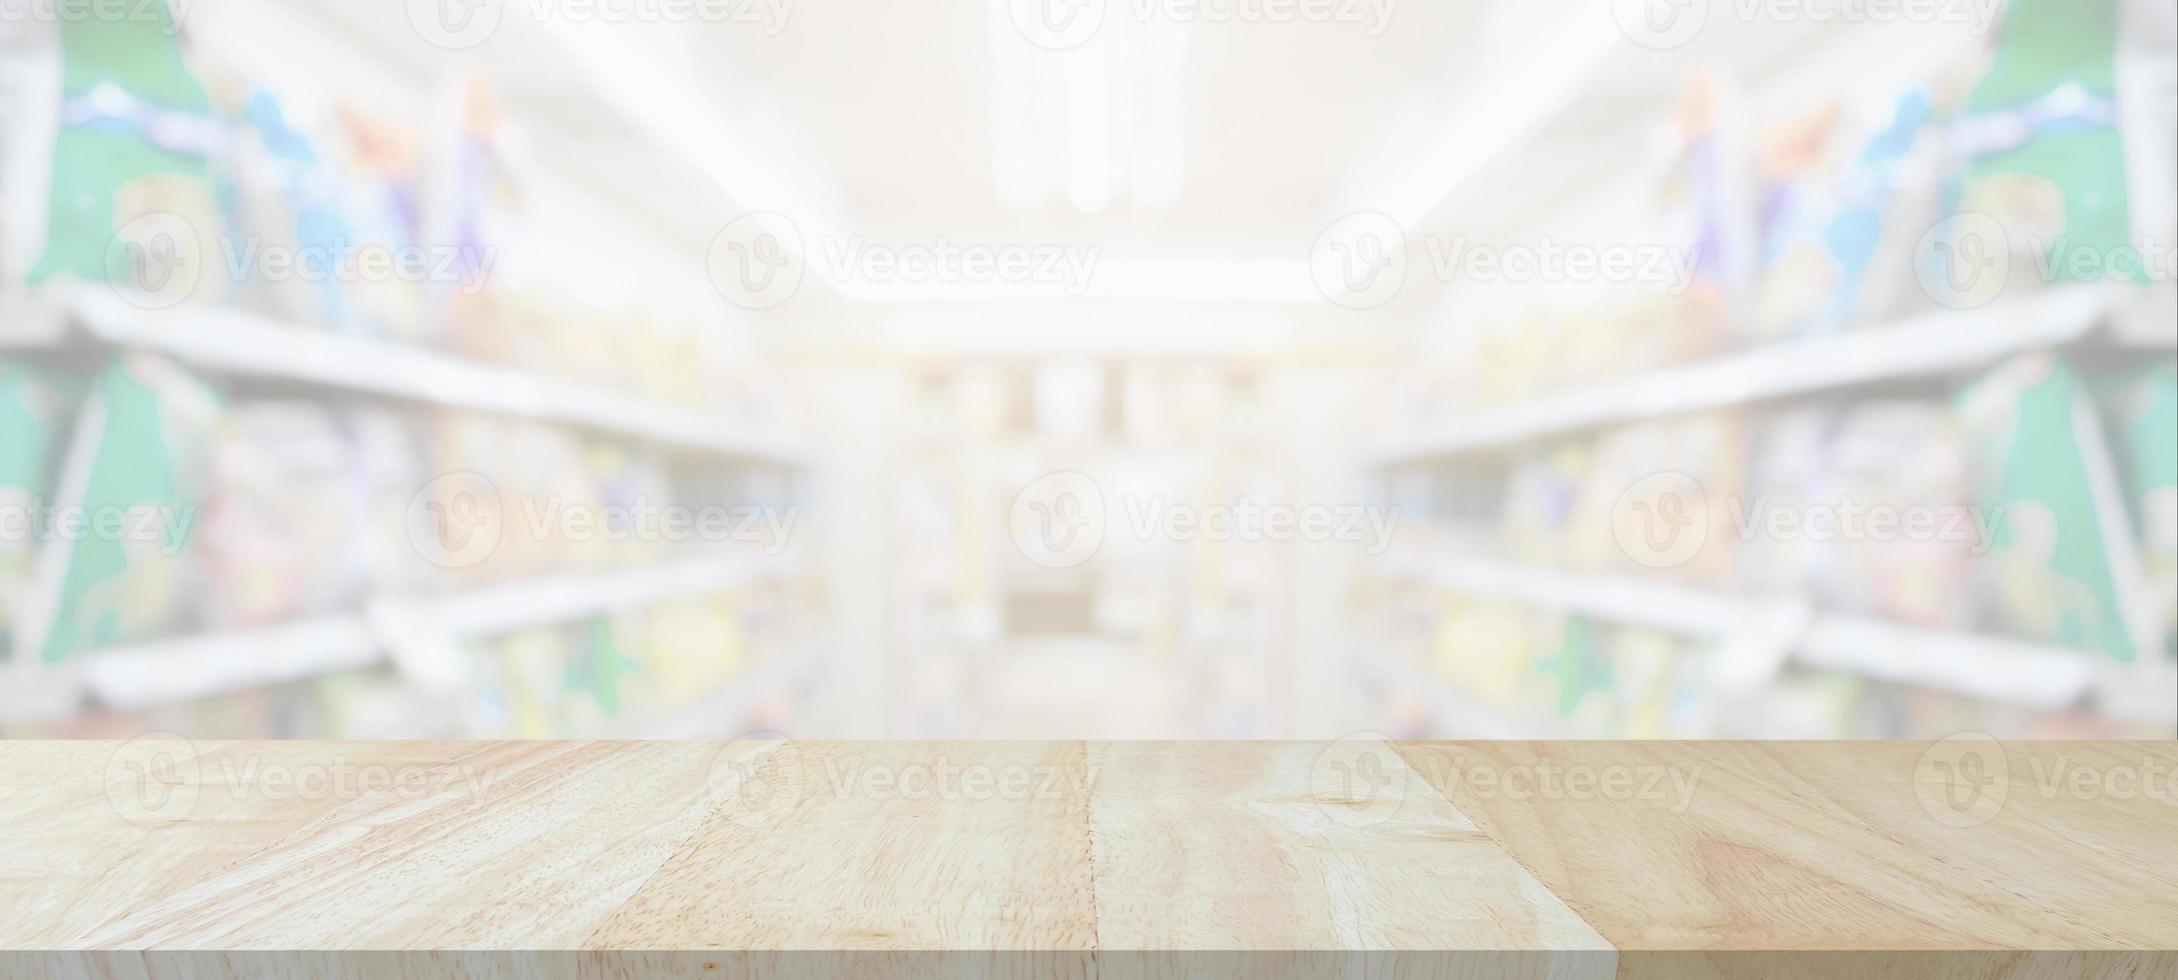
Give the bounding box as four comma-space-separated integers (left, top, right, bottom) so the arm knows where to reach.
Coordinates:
1400, 736, 2178, 978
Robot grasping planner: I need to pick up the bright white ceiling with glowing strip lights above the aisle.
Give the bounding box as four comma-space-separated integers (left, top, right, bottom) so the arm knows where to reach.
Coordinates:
221, 0, 1995, 313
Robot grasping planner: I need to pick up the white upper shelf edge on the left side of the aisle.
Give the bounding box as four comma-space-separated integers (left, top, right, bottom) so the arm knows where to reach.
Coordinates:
21, 287, 802, 464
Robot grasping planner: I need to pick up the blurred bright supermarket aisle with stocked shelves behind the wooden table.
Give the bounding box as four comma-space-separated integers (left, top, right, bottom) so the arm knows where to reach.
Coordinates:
0, 0, 2178, 738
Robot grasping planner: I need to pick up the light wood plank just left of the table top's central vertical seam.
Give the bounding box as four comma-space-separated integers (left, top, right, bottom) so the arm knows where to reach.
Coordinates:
586, 743, 1096, 963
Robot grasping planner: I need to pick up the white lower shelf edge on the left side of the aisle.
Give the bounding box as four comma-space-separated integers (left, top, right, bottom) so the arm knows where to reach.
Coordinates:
21, 558, 805, 710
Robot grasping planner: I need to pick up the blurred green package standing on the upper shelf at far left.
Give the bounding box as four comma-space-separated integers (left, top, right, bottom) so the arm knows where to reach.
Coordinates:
30, 4, 231, 305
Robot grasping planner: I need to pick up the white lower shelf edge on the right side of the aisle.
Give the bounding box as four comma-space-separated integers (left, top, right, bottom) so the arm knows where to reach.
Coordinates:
1390, 550, 2124, 710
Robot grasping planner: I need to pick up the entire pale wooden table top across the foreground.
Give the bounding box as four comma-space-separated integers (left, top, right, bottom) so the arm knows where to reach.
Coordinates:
0, 736, 2178, 978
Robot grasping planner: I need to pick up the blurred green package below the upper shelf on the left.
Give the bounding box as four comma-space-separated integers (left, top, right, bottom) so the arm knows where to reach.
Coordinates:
26, 355, 220, 662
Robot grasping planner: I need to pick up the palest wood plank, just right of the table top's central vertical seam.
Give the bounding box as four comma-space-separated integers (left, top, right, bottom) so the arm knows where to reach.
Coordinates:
1089, 738, 1616, 980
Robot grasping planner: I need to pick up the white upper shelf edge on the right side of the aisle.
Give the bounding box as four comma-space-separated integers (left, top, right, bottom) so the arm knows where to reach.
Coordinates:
1372, 285, 2137, 466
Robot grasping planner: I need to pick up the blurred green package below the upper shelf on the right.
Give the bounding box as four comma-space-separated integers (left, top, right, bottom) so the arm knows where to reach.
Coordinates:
1958, 353, 2139, 660
